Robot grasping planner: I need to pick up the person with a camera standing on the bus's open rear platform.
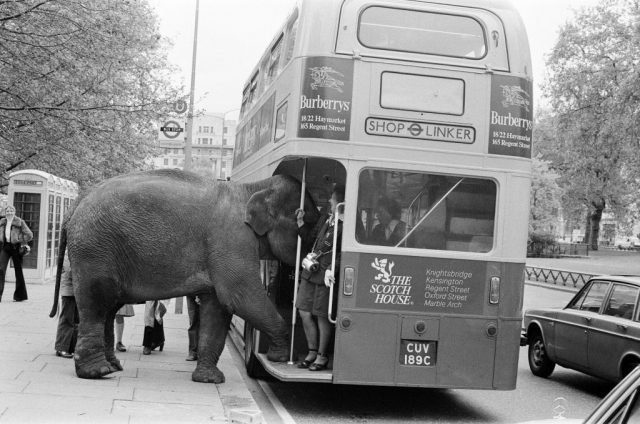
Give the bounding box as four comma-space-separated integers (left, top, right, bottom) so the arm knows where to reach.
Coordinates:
296, 186, 344, 371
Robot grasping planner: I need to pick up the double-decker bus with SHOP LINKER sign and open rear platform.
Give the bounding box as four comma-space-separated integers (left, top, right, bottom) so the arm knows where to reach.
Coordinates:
232, 0, 533, 390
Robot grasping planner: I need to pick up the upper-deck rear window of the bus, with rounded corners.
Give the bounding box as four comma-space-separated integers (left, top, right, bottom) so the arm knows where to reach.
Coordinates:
358, 6, 487, 59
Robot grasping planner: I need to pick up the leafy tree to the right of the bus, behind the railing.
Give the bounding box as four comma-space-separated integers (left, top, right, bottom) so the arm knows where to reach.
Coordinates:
545, 0, 640, 249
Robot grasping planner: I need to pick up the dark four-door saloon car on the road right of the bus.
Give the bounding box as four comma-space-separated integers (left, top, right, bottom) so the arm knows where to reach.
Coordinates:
520, 275, 640, 382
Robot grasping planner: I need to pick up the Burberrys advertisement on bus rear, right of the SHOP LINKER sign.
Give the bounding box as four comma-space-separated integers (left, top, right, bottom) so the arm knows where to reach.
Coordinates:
489, 75, 533, 158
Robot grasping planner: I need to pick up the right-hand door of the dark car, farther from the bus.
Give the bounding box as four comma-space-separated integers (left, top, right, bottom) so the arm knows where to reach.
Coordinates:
588, 283, 640, 380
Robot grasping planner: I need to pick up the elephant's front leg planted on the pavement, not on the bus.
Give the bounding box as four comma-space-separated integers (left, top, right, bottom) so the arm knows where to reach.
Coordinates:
191, 293, 232, 384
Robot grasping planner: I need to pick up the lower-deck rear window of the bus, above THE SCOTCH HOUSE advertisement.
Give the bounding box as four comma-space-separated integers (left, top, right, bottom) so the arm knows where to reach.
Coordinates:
356, 169, 497, 253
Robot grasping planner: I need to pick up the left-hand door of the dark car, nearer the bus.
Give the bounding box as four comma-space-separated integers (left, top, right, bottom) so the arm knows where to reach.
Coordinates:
555, 280, 609, 370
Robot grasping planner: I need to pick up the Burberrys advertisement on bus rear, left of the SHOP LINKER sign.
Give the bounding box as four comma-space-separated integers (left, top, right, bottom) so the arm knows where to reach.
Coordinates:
298, 57, 353, 140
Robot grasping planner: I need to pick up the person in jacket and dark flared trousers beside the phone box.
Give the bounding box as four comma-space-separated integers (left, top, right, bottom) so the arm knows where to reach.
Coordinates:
0, 205, 33, 302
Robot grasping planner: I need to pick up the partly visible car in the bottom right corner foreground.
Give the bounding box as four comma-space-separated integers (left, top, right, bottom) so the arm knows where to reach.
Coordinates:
520, 367, 640, 424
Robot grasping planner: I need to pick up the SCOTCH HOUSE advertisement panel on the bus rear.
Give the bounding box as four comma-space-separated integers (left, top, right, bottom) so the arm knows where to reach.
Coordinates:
356, 255, 487, 314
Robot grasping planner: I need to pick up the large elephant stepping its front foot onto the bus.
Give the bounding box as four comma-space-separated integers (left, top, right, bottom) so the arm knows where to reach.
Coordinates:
52, 170, 320, 383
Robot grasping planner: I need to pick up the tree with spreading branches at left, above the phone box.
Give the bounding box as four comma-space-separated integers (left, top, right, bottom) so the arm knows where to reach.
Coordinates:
0, 0, 181, 184
